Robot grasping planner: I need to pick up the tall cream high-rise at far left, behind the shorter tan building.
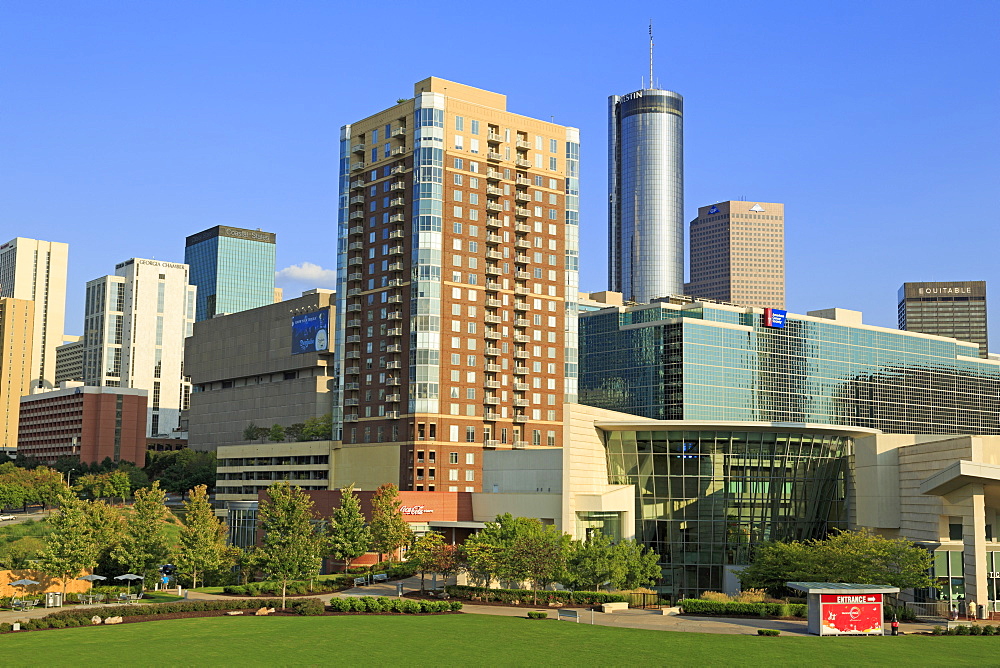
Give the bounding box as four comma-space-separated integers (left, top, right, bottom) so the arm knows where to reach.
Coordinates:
0, 237, 69, 390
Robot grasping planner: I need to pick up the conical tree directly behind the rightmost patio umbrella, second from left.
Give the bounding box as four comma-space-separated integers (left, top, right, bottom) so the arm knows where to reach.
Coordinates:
114, 482, 169, 581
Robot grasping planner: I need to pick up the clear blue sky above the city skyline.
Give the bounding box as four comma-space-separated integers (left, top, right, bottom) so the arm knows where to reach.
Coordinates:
0, 0, 1000, 345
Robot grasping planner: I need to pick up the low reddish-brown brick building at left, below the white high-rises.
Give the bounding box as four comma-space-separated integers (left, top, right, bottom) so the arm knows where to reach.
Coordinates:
17, 383, 147, 467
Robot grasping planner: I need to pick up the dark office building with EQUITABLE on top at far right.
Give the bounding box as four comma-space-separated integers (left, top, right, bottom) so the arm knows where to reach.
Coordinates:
897, 281, 989, 357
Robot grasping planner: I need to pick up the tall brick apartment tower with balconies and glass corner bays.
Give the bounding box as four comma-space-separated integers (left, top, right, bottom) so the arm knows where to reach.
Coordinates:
334, 78, 580, 491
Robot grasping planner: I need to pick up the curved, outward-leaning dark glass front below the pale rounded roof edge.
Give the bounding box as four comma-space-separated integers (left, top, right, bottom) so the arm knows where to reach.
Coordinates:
605, 423, 852, 599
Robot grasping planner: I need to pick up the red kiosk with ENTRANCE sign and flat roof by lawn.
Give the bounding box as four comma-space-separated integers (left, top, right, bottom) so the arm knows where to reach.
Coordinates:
787, 582, 899, 636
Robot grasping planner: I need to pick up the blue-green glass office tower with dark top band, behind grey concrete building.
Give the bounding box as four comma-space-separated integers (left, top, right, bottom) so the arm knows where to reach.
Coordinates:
184, 225, 276, 321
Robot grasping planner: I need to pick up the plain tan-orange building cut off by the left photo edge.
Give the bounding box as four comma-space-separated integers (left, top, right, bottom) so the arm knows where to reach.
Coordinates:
0, 298, 35, 448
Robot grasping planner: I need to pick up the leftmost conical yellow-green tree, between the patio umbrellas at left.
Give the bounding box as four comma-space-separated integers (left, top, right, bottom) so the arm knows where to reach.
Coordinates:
39, 490, 97, 599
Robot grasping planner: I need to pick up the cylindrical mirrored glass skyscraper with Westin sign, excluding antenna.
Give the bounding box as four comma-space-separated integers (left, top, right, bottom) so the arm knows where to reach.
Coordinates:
608, 89, 684, 303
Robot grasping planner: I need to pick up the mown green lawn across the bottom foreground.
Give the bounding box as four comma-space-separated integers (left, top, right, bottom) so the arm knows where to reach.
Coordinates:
0, 615, 1000, 667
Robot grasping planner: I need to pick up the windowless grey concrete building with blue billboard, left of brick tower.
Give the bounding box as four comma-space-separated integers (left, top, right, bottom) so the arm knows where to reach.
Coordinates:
184, 290, 336, 452
